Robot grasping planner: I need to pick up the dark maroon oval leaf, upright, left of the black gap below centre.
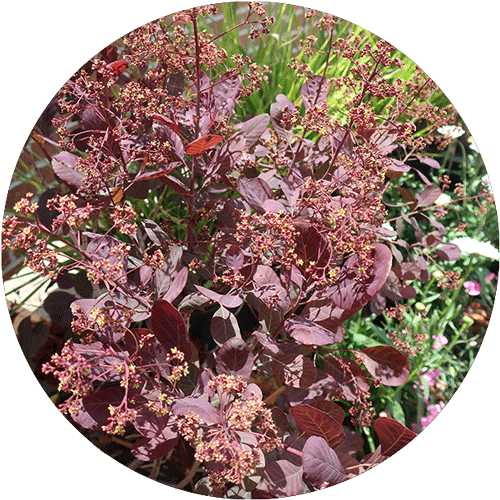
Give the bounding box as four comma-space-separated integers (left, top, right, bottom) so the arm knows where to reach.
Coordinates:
151, 299, 191, 359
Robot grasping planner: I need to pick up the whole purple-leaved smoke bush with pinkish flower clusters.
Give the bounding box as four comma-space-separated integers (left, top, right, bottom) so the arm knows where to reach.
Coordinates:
3, 3, 493, 498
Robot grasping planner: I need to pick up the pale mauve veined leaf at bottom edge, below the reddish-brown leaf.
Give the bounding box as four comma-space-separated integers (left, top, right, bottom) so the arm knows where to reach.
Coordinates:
302, 436, 347, 488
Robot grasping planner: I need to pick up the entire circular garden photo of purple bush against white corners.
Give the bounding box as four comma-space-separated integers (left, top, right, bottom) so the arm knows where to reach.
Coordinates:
2, 2, 500, 498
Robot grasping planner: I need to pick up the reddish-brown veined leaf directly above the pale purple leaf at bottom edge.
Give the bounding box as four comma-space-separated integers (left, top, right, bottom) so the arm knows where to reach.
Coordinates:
290, 404, 344, 448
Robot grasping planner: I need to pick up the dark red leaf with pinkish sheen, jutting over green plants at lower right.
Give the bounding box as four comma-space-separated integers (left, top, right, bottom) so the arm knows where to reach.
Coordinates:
358, 345, 410, 386
